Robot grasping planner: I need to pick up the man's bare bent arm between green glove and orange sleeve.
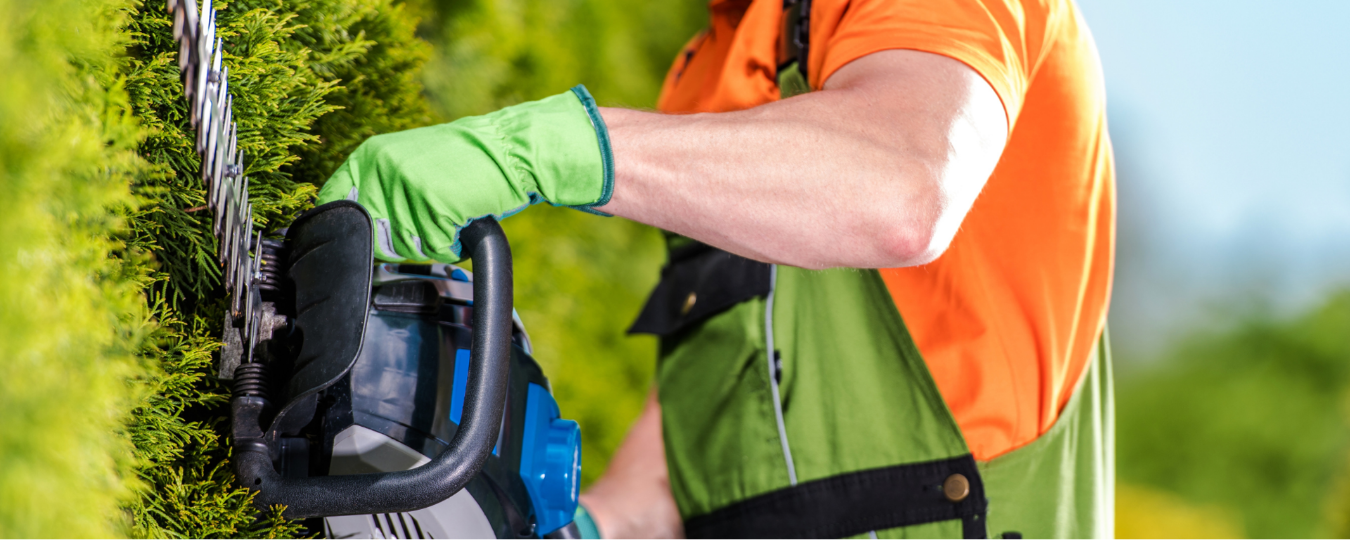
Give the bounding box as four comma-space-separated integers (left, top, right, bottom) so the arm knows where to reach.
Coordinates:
599, 50, 1008, 269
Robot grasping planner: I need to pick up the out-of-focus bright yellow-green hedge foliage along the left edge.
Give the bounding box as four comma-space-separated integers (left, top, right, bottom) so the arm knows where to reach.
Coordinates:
0, 0, 146, 537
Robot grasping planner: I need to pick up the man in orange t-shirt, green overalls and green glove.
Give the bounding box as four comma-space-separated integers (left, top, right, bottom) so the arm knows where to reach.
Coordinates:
320, 0, 1114, 537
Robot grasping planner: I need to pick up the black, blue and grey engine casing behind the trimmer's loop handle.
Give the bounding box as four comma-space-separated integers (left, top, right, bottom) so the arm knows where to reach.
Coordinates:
240, 255, 581, 539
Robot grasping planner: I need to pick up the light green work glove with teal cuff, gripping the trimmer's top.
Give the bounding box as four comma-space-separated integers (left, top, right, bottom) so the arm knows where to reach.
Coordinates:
319, 85, 614, 262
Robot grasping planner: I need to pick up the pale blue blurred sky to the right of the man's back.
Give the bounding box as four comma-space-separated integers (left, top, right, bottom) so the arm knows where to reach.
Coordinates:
1079, 0, 1350, 350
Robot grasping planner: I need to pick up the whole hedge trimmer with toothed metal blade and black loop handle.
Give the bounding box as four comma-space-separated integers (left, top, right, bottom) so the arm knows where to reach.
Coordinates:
167, 0, 581, 537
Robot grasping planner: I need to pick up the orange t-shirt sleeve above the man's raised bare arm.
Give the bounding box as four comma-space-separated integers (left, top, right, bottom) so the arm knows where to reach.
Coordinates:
810, 0, 1045, 126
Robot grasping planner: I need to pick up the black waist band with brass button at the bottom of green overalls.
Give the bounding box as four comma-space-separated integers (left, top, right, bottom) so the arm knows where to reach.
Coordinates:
684, 455, 988, 539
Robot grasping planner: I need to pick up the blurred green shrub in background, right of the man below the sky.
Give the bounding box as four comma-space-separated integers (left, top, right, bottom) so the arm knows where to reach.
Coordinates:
1116, 293, 1350, 537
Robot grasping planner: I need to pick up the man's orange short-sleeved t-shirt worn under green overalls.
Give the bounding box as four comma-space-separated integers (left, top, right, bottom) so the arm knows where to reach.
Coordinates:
657, 0, 1115, 460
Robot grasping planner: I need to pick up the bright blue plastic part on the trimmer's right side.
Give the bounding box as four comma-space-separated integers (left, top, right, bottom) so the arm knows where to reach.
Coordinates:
520, 383, 582, 535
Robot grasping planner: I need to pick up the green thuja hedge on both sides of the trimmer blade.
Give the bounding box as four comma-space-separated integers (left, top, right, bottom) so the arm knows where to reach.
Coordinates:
0, 0, 431, 537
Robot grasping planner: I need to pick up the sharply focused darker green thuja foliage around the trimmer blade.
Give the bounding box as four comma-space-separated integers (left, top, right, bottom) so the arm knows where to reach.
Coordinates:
123, 0, 429, 537
